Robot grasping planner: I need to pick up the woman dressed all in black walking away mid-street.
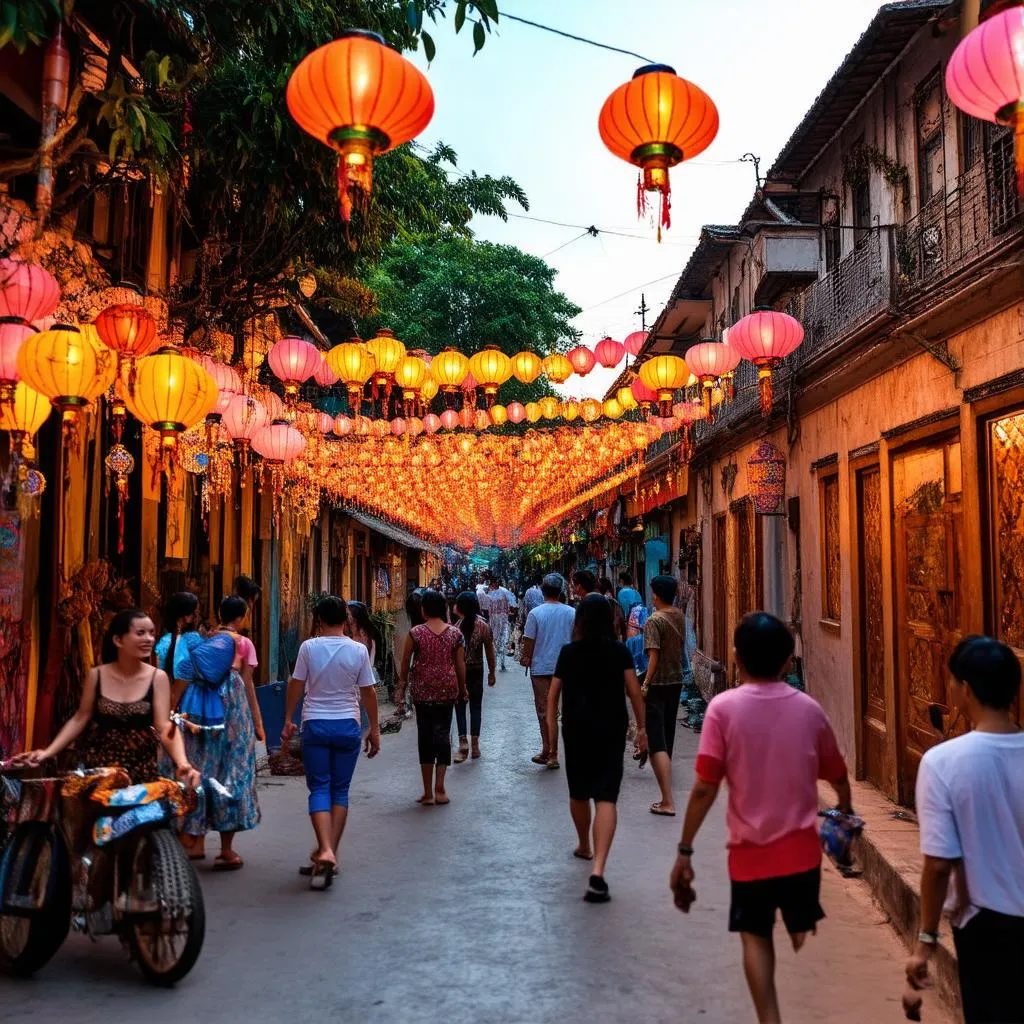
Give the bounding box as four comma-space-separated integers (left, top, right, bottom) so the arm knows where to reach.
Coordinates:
548, 594, 647, 903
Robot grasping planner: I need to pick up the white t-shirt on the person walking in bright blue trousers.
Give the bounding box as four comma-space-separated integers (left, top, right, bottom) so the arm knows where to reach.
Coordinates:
292, 637, 374, 722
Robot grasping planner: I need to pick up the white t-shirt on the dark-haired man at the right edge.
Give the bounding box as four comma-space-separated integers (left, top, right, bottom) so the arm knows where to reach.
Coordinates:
916, 732, 1024, 928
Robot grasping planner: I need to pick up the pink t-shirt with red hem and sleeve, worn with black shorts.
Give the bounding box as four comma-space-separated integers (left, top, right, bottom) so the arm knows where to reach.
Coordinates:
696, 683, 846, 882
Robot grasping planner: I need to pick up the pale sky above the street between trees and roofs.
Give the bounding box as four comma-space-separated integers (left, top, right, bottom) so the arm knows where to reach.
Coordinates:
411, 0, 880, 397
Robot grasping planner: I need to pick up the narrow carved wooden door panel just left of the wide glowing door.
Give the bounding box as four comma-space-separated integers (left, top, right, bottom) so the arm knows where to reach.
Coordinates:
857, 466, 888, 790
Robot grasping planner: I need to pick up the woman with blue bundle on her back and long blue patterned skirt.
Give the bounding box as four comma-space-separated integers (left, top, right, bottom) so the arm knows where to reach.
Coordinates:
181, 594, 264, 871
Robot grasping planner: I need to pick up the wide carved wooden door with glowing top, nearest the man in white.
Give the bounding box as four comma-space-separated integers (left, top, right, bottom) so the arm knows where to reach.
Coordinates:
893, 440, 963, 804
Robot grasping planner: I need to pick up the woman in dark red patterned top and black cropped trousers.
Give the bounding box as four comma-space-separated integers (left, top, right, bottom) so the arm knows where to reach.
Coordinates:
397, 590, 469, 807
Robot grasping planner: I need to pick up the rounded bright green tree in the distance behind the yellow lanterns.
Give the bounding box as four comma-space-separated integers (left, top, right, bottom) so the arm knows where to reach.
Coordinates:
360, 232, 580, 403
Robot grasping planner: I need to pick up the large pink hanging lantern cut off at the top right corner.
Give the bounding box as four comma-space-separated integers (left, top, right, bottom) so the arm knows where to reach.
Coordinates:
946, 5, 1024, 196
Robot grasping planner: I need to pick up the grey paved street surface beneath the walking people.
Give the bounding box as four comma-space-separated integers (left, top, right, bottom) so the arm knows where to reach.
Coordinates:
6, 669, 948, 1024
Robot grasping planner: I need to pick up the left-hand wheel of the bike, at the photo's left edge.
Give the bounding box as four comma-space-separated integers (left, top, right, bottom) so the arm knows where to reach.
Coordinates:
0, 821, 72, 976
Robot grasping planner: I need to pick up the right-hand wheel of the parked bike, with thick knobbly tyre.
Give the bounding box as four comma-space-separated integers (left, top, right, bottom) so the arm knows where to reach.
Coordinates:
128, 828, 206, 987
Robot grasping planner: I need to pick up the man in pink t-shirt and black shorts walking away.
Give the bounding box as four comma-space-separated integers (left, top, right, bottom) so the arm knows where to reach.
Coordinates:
669, 611, 853, 1024
